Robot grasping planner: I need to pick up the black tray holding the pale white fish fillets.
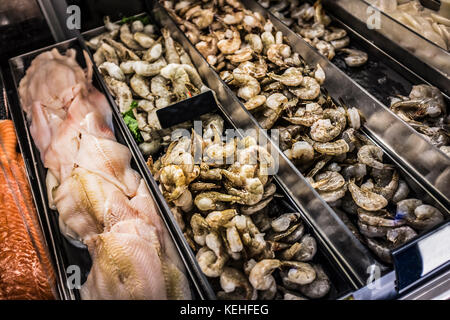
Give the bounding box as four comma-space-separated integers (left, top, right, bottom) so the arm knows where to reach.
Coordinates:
9, 39, 200, 300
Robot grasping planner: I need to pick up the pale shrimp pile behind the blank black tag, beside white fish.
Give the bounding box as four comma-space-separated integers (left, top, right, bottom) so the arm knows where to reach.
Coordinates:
87, 17, 208, 155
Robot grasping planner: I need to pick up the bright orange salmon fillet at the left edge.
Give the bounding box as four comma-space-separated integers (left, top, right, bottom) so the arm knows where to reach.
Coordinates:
0, 120, 54, 300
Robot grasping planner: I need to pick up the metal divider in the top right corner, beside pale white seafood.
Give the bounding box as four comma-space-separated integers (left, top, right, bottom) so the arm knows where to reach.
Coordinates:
323, 0, 450, 96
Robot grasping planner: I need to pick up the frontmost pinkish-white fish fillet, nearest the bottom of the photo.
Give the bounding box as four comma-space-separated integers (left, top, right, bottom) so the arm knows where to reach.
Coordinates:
80, 232, 167, 300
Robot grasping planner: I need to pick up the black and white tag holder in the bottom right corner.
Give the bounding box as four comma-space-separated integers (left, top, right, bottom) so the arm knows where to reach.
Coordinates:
392, 221, 450, 295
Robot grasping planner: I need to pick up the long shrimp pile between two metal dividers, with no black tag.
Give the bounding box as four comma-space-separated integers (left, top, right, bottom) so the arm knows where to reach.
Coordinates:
164, 0, 444, 263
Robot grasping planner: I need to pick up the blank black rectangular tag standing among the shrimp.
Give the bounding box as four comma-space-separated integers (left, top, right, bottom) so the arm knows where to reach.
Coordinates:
156, 90, 219, 129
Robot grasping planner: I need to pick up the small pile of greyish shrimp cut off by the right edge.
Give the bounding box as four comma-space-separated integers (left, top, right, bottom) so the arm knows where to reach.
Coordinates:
391, 84, 450, 157
